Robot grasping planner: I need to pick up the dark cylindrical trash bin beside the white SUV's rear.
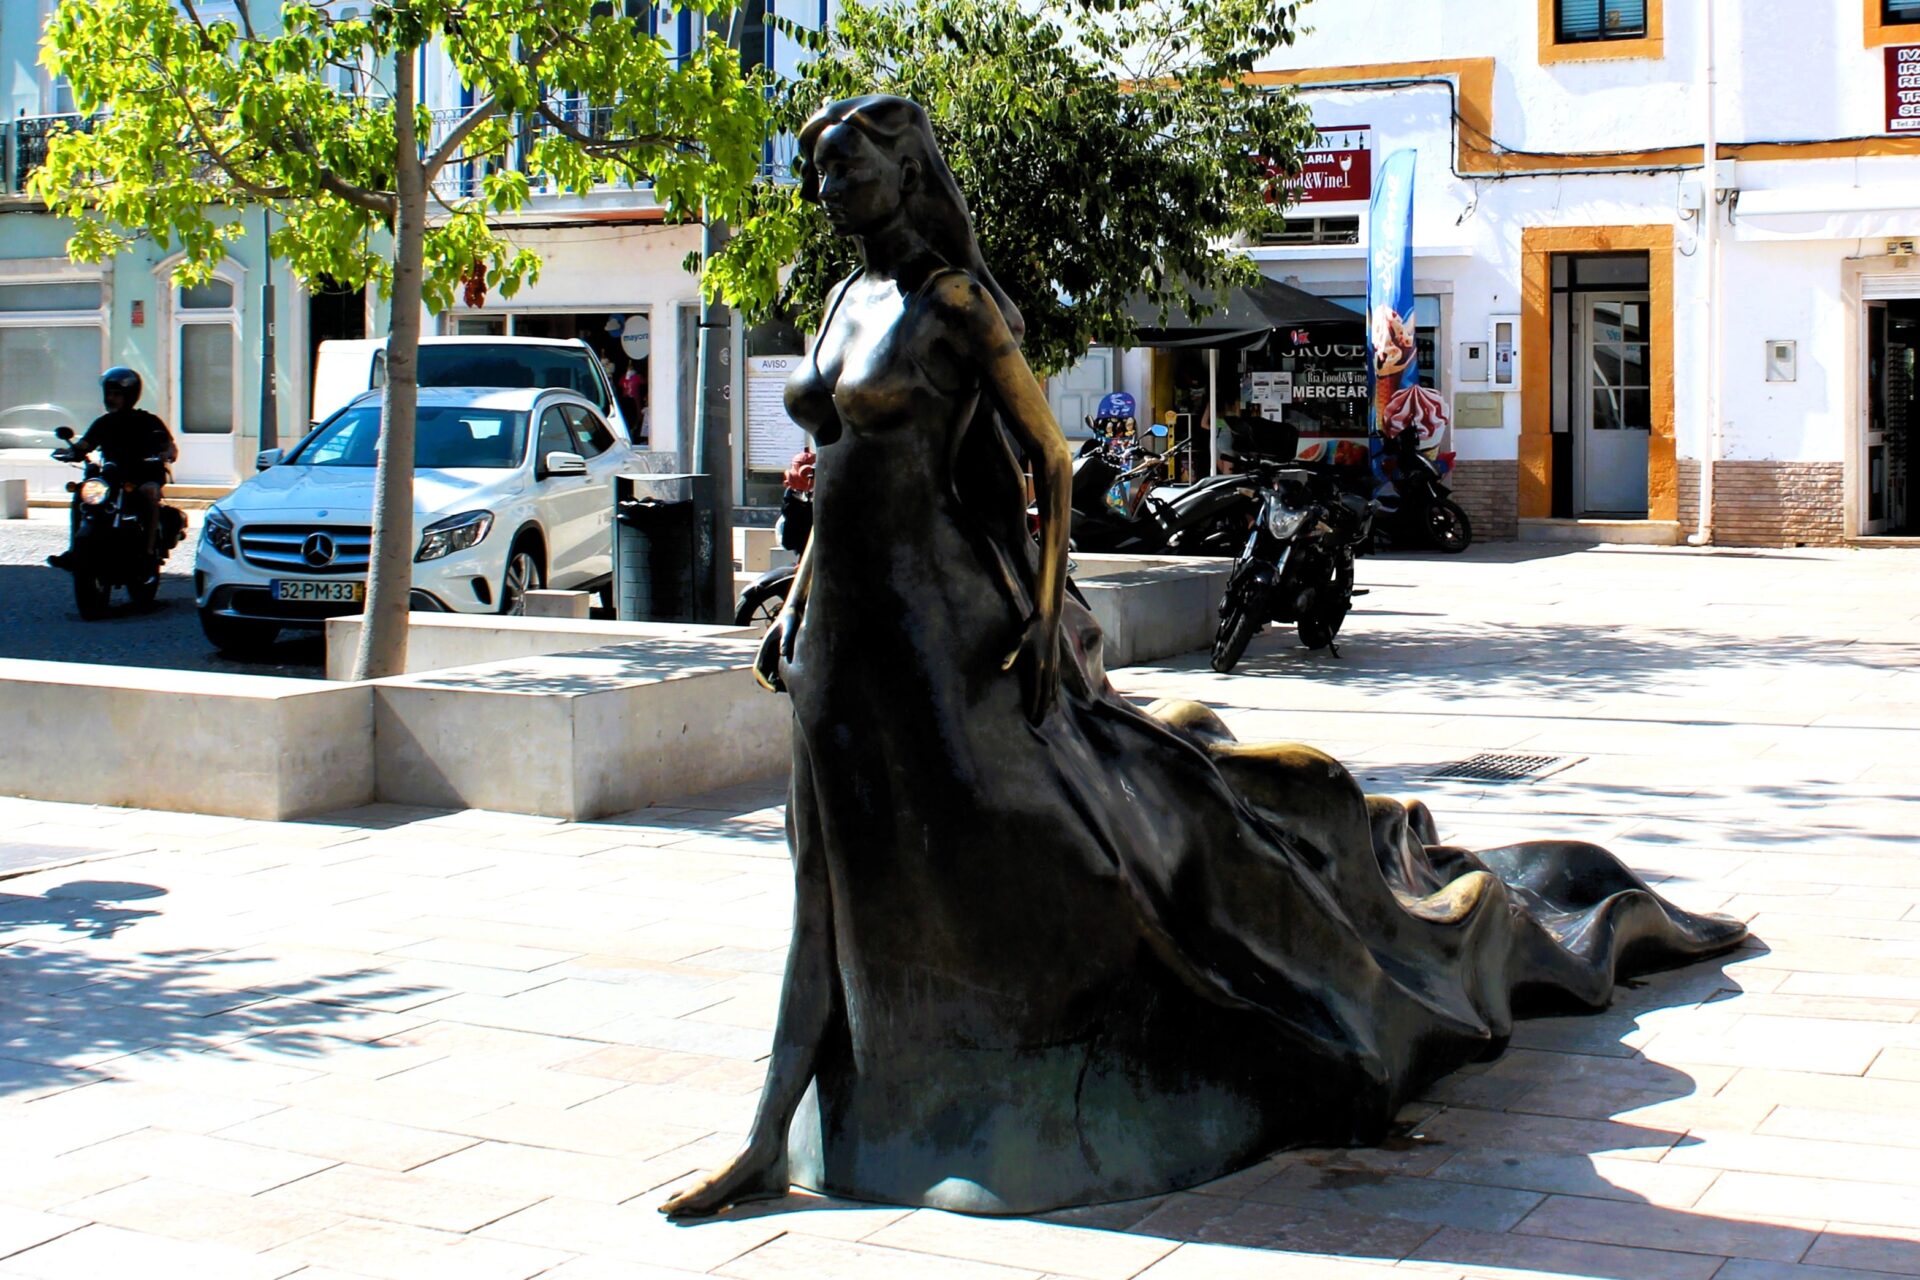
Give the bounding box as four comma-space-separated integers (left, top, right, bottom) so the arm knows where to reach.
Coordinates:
612, 474, 712, 622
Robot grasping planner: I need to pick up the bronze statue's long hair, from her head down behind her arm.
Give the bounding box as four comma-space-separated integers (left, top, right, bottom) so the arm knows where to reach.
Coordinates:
801, 94, 1035, 618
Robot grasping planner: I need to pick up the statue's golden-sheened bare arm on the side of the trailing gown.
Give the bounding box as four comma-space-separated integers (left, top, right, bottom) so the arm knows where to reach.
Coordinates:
933, 273, 1073, 723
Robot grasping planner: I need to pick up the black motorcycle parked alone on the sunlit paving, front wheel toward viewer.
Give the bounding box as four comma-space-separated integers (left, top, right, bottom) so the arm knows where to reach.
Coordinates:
1213, 464, 1379, 674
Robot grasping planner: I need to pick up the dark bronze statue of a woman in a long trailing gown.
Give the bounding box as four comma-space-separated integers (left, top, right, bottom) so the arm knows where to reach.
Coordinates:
664, 96, 1743, 1215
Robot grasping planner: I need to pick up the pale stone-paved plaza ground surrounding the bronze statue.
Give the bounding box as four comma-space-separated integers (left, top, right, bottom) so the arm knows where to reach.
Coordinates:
0, 545, 1920, 1280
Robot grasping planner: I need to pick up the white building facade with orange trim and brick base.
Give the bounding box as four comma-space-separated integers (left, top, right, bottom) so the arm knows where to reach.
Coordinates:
1100, 0, 1920, 545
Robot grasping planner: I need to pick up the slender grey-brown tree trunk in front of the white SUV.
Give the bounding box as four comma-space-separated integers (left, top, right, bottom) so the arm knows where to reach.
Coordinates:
353, 46, 426, 679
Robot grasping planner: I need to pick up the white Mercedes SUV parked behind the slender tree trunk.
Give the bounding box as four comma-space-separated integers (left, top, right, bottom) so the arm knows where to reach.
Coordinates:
194, 388, 634, 651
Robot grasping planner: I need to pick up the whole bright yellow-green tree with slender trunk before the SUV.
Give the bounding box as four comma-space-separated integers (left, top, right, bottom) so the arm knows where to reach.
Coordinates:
33, 0, 766, 679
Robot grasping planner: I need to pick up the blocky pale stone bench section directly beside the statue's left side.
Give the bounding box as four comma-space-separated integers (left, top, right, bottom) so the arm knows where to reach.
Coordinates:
372, 637, 791, 821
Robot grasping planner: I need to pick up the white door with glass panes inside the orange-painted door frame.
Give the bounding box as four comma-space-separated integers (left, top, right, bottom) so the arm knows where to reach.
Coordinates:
1574, 294, 1653, 516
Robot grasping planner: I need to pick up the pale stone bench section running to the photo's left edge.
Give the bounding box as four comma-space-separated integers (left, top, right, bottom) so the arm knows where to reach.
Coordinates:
0, 658, 374, 819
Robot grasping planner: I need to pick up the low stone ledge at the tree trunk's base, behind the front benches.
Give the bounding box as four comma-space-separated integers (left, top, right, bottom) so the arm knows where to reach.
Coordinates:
326, 614, 753, 679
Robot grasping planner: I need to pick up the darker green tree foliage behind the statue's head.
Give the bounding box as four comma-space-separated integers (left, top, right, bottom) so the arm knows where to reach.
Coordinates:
707, 0, 1313, 374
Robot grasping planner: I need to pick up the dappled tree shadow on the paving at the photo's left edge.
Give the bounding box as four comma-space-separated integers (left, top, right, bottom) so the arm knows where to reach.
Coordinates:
0, 881, 432, 1098
